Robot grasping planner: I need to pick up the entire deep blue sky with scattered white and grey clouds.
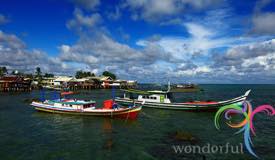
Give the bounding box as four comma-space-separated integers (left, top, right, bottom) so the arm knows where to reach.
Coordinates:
0, 0, 275, 83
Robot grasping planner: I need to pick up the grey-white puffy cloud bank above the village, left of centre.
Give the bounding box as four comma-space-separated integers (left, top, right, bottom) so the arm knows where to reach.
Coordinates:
60, 33, 170, 69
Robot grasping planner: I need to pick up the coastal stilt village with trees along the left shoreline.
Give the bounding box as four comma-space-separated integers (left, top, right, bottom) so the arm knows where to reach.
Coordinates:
0, 67, 137, 92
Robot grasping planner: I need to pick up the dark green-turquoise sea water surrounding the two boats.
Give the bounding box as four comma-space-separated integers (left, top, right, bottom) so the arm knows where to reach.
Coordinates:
0, 85, 275, 160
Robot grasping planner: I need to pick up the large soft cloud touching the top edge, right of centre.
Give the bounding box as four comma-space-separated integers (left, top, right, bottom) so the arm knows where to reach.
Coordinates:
123, 0, 220, 21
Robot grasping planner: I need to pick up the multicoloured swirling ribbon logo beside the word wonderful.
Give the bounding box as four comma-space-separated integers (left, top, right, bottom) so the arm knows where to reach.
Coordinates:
215, 101, 275, 158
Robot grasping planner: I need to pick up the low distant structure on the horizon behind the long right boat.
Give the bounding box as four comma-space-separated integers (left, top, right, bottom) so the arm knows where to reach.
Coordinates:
170, 83, 200, 92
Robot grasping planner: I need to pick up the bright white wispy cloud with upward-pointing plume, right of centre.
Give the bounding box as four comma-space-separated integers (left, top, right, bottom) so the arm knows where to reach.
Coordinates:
136, 23, 232, 60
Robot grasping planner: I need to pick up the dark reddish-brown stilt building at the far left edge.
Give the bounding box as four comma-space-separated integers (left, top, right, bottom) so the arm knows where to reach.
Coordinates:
0, 76, 31, 91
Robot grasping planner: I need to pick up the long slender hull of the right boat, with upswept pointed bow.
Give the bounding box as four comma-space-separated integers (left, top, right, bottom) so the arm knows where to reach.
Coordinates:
115, 91, 250, 111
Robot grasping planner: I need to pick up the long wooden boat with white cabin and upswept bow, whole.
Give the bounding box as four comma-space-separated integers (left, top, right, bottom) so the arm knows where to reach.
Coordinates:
115, 90, 250, 111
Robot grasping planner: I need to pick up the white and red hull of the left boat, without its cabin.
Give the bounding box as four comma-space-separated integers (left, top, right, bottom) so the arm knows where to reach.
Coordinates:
31, 102, 142, 119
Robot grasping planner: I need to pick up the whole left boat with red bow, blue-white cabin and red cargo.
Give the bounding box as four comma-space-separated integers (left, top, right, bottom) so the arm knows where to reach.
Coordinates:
31, 99, 142, 119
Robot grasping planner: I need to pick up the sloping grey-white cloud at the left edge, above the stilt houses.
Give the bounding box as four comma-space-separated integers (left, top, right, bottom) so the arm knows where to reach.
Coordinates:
0, 31, 74, 73
